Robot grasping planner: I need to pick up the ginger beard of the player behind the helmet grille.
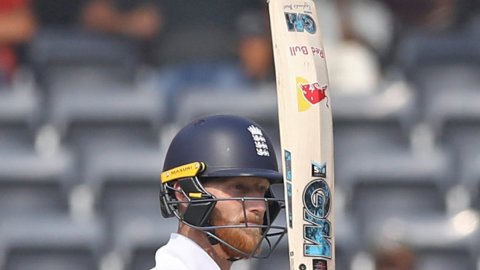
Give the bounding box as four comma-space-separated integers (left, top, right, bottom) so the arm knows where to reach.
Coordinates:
211, 208, 263, 258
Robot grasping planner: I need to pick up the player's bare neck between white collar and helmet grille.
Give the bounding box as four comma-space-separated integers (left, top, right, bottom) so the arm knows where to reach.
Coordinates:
178, 224, 233, 270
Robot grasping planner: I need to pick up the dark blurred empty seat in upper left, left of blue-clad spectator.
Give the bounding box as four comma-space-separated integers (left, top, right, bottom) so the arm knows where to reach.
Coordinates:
27, 28, 139, 91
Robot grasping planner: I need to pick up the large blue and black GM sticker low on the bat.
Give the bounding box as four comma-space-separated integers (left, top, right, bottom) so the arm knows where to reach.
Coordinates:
303, 179, 332, 258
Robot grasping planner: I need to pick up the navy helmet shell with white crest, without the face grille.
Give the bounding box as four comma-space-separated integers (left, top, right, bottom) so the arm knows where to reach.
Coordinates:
163, 115, 282, 183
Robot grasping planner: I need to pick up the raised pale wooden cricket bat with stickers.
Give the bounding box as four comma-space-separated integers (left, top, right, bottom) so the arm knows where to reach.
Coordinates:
269, 0, 335, 270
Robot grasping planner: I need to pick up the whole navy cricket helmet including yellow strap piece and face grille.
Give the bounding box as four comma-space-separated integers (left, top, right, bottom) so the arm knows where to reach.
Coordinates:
160, 115, 286, 260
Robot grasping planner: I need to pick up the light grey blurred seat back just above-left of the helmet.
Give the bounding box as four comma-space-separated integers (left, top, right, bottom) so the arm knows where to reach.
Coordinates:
47, 82, 163, 139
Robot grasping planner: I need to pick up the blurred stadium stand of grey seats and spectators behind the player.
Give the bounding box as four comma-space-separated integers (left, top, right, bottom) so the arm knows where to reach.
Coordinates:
0, 0, 480, 270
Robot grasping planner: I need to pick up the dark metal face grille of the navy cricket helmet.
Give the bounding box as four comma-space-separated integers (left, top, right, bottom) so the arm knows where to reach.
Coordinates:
160, 177, 287, 260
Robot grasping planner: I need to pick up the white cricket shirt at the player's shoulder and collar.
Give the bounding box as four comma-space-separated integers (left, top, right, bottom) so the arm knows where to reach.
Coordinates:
152, 233, 220, 270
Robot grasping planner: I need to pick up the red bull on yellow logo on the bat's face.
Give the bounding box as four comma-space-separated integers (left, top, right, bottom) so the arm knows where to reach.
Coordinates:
296, 77, 328, 112
